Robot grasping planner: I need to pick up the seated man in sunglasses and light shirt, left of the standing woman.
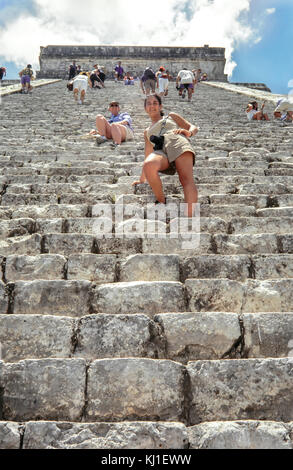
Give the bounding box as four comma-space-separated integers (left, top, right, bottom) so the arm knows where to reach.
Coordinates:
90, 101, 133, 147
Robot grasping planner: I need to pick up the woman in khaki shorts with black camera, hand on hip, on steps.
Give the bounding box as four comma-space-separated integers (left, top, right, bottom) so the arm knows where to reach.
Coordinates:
132, 95, 198, 217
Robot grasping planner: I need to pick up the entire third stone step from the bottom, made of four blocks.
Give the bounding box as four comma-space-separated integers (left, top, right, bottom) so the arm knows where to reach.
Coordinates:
0, 312, 293, 364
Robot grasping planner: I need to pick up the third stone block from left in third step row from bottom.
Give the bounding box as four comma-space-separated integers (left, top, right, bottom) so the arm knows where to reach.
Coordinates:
154, 312, 241, 363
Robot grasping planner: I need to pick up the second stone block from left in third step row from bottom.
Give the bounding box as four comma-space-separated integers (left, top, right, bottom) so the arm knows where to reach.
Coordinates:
74, 314, 163, 359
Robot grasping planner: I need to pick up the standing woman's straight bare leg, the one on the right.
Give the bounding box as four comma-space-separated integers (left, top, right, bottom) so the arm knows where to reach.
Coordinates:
175, 152, 198, 217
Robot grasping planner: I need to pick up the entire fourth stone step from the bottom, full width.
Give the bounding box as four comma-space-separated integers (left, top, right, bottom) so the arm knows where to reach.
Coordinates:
5, 278, 293, 317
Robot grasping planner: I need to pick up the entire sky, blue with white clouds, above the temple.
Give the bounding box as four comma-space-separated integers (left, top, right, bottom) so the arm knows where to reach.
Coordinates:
0, 0, 293, 94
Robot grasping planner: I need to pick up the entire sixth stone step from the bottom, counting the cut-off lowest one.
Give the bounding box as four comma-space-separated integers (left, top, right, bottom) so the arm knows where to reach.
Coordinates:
0, 232, 293, 257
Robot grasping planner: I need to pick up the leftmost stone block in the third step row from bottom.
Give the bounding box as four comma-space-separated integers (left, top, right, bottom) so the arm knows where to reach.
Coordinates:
0, 315, 75, 362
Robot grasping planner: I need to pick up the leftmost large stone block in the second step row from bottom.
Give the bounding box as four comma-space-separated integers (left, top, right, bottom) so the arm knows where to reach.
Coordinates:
1, 359, 86, 421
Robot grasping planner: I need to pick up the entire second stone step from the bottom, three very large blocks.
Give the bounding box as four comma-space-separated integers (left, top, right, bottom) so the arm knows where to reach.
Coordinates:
0, 358, 292, 425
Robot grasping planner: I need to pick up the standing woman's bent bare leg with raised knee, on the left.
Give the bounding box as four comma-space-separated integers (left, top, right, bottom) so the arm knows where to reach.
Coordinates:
143, 153, 169, 203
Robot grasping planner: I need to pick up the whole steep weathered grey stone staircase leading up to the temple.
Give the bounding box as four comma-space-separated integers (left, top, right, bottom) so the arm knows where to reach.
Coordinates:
0, 82, 293, 449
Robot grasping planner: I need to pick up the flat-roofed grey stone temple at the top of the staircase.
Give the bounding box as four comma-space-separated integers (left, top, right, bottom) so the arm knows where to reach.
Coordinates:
38, 45, 227, 82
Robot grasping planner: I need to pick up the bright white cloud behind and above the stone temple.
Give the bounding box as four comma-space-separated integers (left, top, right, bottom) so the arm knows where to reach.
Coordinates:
0, 0, 255, 74
